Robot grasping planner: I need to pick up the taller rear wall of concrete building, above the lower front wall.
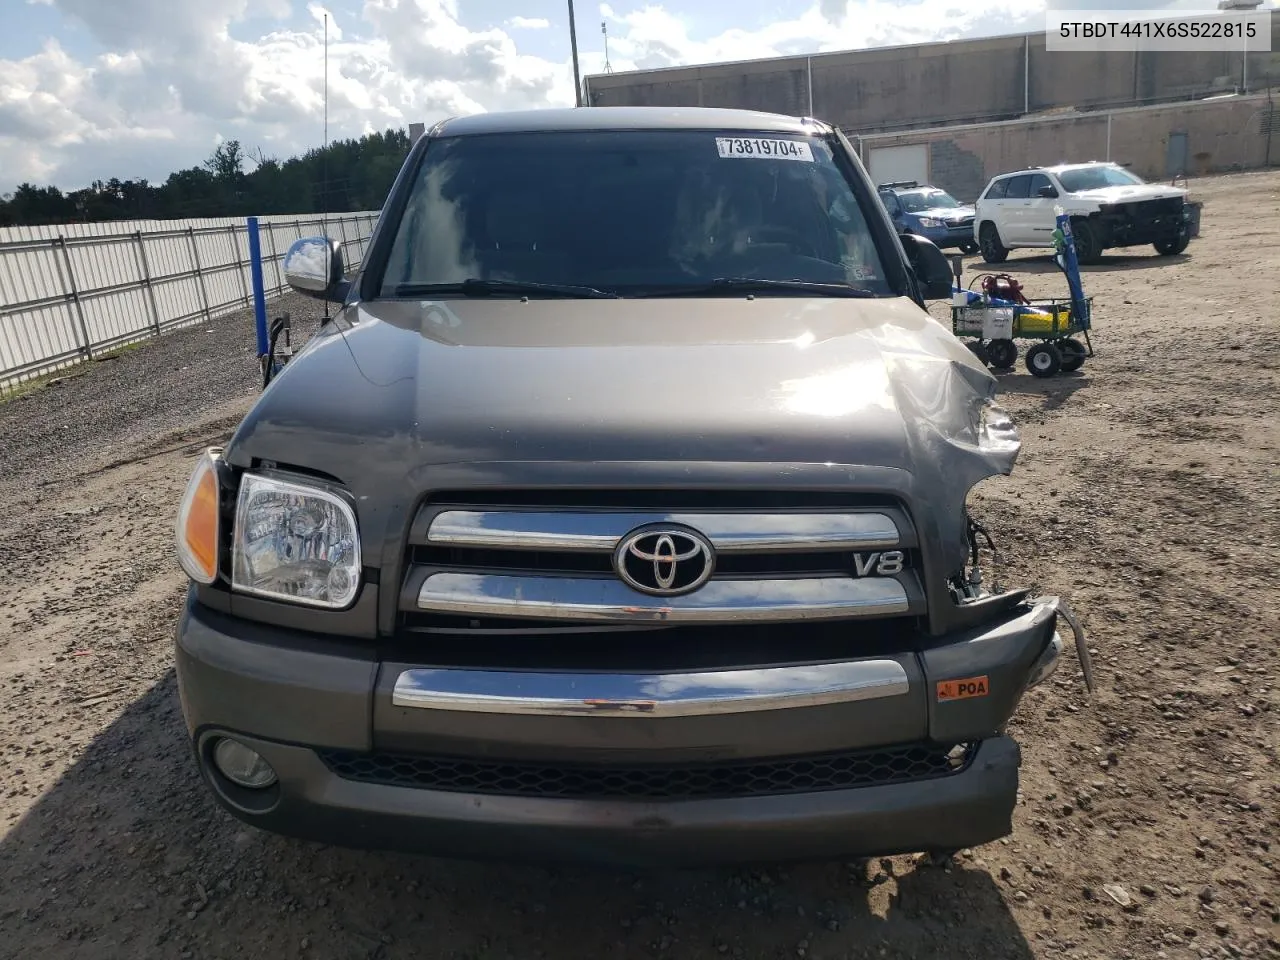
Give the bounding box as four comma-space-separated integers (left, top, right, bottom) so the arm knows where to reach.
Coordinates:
585, 17, 1280, 133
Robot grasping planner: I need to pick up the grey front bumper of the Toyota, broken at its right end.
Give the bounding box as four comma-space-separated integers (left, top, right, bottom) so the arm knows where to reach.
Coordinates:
177, 595, 1061, 865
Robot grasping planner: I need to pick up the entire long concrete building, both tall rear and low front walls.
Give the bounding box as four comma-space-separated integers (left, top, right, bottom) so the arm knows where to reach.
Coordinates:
586, 15, 1280, 200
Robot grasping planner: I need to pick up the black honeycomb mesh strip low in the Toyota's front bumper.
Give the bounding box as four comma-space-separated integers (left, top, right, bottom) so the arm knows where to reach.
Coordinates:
317, 744, 975, 800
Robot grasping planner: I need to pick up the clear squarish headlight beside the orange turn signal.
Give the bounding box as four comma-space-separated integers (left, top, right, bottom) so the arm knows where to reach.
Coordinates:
232, 474, 361, 608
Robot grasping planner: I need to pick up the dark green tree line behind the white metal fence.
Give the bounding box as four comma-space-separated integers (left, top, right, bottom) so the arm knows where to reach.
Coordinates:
0, 129, 410, 227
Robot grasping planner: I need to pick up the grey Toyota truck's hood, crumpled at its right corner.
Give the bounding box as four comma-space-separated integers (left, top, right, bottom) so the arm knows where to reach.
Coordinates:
227, 297, 1019, 560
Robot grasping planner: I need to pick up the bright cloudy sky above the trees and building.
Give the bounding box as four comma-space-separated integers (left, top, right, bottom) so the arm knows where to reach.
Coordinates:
0, 0, 1264, 193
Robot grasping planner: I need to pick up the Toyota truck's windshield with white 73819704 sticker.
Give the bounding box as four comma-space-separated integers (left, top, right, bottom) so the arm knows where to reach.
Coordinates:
380, 129, 892, 297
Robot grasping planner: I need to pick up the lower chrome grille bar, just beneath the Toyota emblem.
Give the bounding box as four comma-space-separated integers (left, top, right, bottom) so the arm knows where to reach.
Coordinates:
417, 572, 911, 623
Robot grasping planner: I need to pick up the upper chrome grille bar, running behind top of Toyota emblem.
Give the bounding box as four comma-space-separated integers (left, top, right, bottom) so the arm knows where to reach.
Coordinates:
426, 509, 902, 553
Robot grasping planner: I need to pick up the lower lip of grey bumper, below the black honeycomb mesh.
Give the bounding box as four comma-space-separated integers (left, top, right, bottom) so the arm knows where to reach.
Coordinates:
186, 737, 1020, 867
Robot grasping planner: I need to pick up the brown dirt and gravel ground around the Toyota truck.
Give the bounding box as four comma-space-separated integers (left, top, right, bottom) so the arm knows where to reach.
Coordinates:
0, 173, 1280, 960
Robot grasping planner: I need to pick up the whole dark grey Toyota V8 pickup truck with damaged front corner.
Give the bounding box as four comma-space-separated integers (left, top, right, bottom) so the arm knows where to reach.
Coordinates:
177, 108, 1079, 864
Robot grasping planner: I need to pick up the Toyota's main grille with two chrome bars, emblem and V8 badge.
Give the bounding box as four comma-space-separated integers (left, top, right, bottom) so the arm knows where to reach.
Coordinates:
398, 490, 924, 647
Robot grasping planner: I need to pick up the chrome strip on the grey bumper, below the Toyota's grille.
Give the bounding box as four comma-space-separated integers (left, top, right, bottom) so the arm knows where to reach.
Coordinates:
392, 660, 910, 717
